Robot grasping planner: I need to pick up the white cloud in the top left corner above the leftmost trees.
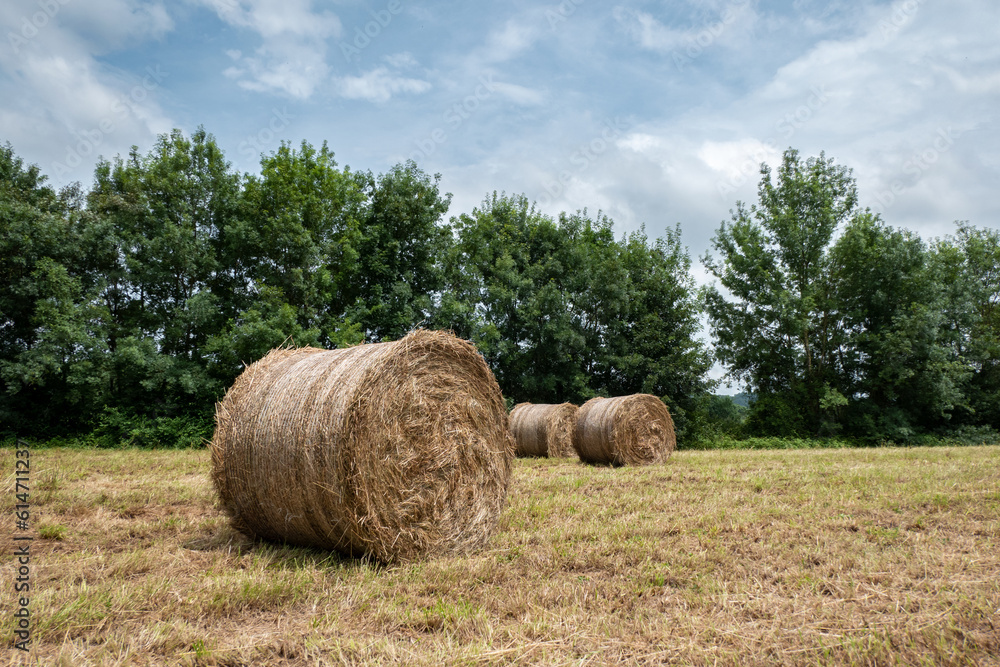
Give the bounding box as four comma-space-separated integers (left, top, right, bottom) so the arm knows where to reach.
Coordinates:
0, 0, 174, 183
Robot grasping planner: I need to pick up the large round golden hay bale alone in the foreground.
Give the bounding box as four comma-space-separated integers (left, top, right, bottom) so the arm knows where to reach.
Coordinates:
211, 331, 514, 562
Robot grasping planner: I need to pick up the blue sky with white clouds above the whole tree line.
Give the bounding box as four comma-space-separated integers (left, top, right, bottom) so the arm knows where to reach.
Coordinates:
0, 0, 1000, 384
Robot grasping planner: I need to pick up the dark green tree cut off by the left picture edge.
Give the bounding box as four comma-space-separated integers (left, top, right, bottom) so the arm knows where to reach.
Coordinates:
0, 144, 106, 434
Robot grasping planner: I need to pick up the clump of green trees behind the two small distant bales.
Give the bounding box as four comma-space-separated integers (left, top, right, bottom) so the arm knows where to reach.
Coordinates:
438, 193, 710, 431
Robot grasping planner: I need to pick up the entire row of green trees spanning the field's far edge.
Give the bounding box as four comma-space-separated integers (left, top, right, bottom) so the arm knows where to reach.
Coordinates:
0, 128, 1000, 444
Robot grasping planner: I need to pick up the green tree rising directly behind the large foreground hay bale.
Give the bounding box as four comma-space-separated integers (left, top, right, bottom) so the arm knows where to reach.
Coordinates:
205, 141, 363, 386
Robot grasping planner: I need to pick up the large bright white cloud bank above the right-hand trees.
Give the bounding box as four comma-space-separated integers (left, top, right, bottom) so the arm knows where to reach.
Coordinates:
560, 0, 1000, 254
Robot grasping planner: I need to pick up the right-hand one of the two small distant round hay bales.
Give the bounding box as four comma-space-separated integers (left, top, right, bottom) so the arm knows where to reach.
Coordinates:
573, 394, 677, 465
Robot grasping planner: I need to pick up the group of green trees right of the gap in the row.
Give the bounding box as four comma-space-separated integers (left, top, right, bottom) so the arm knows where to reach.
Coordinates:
704, 150, 997, 441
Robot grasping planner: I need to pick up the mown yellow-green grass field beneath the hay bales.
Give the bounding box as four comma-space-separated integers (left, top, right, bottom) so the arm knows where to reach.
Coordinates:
0, 447, 1000, 665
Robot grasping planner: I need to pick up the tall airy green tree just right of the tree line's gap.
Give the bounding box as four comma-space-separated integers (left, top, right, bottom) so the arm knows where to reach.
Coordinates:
703, 149, 857, 434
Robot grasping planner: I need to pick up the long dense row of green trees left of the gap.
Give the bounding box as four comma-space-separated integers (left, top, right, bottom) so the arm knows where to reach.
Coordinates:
0, 129, 711, 441
